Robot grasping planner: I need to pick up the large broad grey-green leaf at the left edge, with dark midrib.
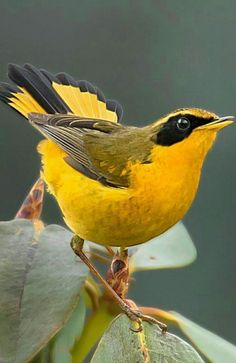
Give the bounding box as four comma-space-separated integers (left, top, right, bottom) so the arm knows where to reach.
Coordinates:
0, 219, 87, 363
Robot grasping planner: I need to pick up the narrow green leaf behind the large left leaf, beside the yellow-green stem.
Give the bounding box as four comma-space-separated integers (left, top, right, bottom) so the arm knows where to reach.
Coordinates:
51, 299, 86, 363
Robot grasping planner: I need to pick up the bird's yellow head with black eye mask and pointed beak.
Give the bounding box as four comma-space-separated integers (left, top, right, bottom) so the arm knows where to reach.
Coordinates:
148, 108, 234, 165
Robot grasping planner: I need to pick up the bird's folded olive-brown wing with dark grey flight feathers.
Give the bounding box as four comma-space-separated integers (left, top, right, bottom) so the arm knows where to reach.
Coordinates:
29, 113, 133, 187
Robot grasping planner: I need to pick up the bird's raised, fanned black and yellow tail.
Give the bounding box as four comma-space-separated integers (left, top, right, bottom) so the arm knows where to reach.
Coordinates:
0, 64, 122, 122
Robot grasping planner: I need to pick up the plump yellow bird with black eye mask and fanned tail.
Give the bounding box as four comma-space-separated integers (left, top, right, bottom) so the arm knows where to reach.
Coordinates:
0, 64, 233, 328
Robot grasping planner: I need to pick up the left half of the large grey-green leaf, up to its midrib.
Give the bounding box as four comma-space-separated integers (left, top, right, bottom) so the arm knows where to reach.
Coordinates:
0, 220, 34, 363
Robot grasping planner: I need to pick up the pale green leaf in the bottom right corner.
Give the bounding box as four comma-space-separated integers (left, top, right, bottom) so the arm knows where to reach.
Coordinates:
170, 311, 236, 363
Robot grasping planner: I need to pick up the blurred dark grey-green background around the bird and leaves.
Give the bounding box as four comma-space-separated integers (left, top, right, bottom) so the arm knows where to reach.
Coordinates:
0, 0, 236, 352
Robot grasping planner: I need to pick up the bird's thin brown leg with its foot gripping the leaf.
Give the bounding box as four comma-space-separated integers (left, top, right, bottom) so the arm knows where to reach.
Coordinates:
71, 235, 166, 332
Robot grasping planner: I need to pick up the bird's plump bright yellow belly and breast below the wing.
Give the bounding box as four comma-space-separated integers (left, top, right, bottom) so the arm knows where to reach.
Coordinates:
39, 140, 203, 246
